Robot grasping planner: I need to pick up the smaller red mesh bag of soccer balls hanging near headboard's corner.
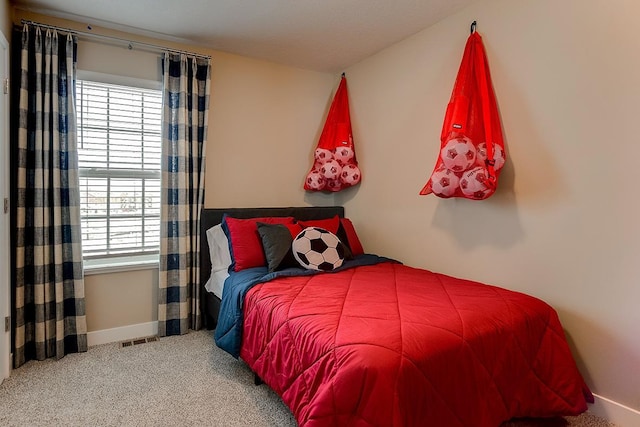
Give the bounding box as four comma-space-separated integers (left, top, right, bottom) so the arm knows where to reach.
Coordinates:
304, 74, 362, 192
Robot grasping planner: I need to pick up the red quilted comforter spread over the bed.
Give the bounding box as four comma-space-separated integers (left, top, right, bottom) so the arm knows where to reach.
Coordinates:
240, 262, 591, 427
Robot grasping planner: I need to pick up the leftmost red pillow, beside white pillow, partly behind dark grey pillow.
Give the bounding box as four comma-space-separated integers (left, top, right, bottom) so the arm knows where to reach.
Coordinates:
222, 215, 295, 271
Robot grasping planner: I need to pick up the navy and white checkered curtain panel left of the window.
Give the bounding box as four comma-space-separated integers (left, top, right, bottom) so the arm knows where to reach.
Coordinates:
13, 25, 87, 367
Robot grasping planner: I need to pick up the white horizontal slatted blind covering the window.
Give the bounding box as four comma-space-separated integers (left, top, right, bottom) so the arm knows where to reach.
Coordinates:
76, 80, 162, 259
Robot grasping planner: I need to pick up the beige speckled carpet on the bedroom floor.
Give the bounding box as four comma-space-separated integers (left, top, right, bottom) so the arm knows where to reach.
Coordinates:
0, 331, 612, 427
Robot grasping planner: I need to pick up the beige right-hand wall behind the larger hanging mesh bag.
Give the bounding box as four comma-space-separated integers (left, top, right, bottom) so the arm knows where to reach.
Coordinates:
337, 0, 640, 410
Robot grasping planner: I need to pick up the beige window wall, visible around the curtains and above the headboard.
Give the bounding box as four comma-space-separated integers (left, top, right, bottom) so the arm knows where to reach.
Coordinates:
15, 10, 339, 332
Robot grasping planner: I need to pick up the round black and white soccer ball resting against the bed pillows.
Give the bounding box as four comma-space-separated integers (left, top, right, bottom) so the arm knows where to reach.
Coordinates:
291, 227, 345, 271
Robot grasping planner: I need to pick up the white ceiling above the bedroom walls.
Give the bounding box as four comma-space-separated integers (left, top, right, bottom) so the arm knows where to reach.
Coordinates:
11, 0, 475, 72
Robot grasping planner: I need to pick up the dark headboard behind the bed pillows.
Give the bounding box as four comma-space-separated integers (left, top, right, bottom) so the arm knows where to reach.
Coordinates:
200, 206, 344, 286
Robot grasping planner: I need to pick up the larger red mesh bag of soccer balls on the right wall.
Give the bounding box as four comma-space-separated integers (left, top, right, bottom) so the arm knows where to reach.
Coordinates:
420, 22, 507, 200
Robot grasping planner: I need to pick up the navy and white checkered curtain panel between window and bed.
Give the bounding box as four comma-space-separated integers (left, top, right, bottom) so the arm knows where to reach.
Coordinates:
158, 53, 211, 336
